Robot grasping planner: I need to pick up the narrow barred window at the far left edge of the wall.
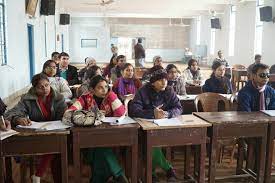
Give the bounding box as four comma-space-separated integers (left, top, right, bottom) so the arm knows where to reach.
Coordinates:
0, 0, 7, 65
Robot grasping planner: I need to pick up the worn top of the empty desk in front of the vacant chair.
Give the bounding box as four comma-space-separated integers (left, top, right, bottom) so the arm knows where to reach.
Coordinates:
193, 111, 270, 124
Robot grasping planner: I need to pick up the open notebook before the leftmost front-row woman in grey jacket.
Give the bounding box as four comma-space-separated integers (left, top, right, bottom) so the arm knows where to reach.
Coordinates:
17, 121, 71, 131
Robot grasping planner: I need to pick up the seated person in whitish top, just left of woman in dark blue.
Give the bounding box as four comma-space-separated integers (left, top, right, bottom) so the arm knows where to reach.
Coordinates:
183, 59, 202, 85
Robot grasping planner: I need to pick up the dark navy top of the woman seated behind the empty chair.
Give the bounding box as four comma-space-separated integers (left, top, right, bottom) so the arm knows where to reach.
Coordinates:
202, 75, 233, 94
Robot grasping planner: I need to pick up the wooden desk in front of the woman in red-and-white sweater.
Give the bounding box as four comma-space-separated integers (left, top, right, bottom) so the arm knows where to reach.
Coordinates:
71, 124, 139, 182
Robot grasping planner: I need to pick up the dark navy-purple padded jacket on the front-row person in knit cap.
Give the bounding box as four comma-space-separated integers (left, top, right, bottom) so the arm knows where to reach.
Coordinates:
129, 83, 182, 119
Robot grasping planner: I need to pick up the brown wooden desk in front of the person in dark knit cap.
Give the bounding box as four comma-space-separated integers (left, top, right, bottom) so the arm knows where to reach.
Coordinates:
139, 115, 210, 183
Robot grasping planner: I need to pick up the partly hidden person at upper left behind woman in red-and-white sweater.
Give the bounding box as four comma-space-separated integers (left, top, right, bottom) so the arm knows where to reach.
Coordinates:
76, 65, 102, 97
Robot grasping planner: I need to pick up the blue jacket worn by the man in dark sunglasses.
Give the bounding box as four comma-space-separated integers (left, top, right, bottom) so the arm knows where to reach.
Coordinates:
238, 81, 275, 112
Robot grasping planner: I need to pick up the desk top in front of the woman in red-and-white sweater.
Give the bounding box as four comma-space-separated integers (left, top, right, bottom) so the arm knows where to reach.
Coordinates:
71, 123, 140, 132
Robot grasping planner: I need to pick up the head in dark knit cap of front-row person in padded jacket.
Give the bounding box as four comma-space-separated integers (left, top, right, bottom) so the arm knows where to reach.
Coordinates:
149, 65, 167, 92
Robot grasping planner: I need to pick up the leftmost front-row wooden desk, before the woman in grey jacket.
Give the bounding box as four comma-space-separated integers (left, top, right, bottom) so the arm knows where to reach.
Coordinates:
0, 130, 70, 183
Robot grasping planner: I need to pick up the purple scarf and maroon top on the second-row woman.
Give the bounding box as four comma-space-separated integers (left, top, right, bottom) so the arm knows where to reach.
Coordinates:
118, 77, 136, 96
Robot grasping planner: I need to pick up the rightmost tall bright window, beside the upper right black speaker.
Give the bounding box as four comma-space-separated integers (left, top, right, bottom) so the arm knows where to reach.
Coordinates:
254, 0, 264, 54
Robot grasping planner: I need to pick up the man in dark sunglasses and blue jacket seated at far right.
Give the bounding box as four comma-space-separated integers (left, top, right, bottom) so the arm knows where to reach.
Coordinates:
238, 63, 275, 112
